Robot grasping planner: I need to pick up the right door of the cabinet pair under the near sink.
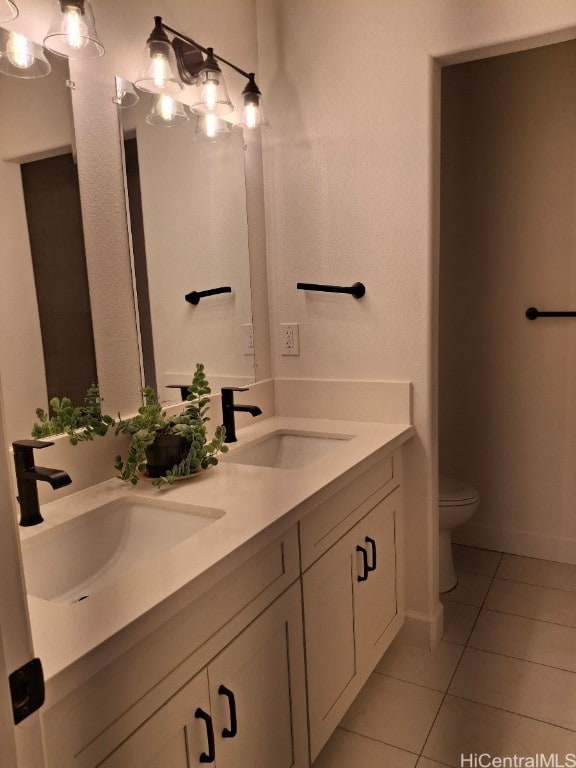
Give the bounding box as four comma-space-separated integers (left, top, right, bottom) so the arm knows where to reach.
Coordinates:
208, 584, 308, 768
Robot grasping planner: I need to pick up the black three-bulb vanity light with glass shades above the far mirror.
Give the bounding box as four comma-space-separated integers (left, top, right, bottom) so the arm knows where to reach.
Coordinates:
135, 16, 269, 130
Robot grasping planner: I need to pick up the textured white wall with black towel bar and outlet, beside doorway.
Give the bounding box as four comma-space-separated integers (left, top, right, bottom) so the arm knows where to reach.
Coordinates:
258, 0, 576, 632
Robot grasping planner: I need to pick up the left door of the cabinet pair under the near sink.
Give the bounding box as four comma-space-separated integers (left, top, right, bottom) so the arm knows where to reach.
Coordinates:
101, 669, 214, 768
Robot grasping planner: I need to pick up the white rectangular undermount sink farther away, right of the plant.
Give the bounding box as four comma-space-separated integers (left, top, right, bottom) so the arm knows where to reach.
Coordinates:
222, 430, 353, 469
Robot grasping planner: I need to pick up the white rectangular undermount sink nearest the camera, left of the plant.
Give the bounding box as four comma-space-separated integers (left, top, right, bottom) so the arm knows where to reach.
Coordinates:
22, 496, 224, 603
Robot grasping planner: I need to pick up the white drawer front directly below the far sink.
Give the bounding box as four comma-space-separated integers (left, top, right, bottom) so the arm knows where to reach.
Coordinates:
299, 453, 401, 571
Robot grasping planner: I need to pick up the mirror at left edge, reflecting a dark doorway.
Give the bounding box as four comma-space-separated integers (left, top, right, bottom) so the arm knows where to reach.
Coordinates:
0, 46, 97, 442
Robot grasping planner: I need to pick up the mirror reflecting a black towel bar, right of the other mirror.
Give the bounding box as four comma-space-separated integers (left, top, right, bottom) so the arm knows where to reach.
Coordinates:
118, 79, 254, 400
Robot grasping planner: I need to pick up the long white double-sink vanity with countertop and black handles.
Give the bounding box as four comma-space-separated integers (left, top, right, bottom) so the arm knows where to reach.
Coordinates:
23, 418, 413, 768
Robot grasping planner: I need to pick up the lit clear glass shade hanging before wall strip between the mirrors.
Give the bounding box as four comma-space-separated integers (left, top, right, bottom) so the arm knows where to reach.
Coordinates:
44, 0, 104, 59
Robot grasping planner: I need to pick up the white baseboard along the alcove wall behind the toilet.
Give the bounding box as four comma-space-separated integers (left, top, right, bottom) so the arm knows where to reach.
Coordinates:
453, 523, 576, 565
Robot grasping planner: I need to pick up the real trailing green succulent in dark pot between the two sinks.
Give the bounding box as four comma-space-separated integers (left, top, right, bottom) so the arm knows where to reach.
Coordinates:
114, 363, 228, 486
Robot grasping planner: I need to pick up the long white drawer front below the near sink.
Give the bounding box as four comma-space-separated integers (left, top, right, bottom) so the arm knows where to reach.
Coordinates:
42, 528, 299, 768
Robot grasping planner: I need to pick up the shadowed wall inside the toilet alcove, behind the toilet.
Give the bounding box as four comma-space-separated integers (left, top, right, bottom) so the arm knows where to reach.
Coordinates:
439, 41, 576, 563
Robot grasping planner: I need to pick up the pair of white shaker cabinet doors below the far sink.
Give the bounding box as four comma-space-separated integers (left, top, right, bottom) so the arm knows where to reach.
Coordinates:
302, 490, 400, 760
